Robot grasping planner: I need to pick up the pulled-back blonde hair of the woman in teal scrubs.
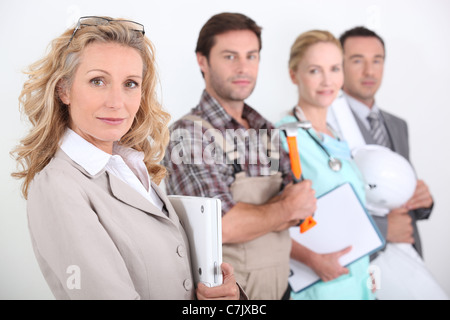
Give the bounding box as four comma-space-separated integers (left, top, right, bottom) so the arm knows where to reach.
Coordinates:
289, 30, 342, 72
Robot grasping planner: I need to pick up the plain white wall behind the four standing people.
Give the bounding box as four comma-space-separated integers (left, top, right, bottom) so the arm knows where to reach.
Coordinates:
0, 0, 450, 299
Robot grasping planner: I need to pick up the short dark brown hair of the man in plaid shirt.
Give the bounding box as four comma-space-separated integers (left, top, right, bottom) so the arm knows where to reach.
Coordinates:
195, 12, 262, 58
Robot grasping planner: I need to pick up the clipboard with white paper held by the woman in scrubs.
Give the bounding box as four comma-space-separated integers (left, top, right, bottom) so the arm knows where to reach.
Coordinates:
289, 183, 385, 292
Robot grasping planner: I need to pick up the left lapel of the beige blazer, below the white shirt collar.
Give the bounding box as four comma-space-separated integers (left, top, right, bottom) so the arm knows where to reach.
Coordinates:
106, 172, 168, 219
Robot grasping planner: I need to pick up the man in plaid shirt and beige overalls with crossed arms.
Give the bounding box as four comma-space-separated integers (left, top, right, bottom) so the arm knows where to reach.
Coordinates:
163, 13, 316, 299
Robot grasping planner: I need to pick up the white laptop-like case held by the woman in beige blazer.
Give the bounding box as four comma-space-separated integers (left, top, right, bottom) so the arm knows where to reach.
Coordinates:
168, 195, 223, 287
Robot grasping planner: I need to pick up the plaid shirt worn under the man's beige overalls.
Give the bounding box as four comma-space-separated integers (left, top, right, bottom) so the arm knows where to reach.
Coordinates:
163, 91, 292, 214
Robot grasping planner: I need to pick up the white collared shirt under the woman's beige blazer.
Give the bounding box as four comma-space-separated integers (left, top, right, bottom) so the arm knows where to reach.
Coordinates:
60, 128, 164, 211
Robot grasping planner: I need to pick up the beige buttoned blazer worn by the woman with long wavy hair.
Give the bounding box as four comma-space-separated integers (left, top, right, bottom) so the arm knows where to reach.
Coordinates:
27, 150, 195, 299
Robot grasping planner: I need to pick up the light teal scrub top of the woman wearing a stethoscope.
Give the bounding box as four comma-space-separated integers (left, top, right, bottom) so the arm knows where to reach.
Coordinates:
277, 116, 375, 300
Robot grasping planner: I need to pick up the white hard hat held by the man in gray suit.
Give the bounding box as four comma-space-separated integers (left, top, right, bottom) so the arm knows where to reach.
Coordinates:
352, 145, 417, 215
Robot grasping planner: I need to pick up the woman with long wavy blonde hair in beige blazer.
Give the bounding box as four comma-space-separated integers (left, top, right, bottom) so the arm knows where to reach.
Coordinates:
13, 17, 239, 299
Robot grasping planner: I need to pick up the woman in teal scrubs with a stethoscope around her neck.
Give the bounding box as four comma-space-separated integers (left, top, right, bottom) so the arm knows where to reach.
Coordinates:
278, 30, 374, 300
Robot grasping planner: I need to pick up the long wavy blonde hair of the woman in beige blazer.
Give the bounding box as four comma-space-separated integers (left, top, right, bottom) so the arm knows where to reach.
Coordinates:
11, 17, 170, 198
